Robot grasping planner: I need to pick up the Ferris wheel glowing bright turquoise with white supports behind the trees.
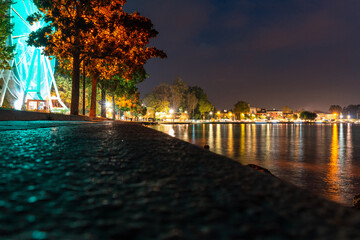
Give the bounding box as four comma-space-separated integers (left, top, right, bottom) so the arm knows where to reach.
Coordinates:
0, 0, 67, 110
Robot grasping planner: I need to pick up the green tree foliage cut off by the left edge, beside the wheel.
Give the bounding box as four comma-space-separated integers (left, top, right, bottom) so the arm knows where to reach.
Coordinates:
0, 0, 14, 70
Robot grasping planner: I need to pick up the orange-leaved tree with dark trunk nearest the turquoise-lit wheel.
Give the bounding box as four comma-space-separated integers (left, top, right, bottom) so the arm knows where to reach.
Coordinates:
28, 0, 99, 115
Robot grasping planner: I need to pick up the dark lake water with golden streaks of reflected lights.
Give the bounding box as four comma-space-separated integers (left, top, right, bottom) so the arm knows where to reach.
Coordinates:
154, 123, 360, 206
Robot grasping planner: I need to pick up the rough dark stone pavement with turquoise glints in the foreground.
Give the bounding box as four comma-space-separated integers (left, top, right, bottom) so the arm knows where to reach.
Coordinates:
0, 122, 360, 239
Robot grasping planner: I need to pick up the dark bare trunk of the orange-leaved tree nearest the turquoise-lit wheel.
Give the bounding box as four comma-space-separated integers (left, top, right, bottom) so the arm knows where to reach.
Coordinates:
70, 52, 81, 115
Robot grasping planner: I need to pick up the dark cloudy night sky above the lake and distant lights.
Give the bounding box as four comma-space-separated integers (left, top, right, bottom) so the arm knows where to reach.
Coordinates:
125, 0, 360, 111
